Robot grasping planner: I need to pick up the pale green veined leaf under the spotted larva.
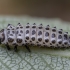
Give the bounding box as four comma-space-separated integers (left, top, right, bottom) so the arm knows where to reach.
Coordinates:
0, 16, 70, 70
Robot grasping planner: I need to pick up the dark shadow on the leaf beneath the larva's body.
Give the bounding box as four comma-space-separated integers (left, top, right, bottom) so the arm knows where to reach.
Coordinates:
0, 45, 70, 52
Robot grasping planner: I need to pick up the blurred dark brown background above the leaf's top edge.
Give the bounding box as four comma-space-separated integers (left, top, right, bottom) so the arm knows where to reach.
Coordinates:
0, 0, 70, 21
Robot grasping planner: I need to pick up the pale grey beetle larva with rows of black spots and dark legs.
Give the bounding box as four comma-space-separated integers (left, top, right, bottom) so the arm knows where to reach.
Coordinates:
0, 23, 70, 52
